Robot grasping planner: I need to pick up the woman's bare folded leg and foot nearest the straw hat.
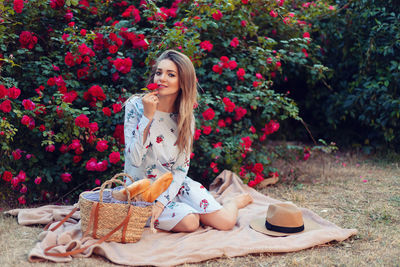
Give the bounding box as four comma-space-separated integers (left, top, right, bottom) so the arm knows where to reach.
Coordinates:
200, 194, 253, 230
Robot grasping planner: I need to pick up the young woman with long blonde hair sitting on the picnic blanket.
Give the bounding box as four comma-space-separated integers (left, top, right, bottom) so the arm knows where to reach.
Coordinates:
124, 50, 252, 232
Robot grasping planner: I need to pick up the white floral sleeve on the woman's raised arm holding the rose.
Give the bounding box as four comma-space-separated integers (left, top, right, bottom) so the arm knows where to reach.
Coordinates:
124, 97, 150, 167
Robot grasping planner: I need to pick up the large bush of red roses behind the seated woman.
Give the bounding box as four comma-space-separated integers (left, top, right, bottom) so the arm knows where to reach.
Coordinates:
0, 0, 331, 204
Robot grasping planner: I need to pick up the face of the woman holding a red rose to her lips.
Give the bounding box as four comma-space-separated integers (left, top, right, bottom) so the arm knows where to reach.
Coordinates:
154, 59, 179, 96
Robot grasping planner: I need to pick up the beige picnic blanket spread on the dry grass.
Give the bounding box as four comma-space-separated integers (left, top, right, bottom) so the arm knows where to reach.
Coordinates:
6, 170, 357, 266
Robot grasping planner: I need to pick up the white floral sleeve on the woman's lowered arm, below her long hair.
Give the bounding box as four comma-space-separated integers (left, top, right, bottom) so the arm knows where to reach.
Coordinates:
157, 118, 194, 206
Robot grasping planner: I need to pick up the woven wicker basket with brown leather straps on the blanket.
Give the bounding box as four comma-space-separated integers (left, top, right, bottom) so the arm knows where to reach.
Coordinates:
79, 173, 152, 243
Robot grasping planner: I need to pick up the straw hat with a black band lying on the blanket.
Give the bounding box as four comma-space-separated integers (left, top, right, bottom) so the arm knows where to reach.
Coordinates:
250, 202, 320, 236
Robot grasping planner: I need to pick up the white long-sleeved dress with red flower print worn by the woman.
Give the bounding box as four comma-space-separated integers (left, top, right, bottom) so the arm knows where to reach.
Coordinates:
124, 97, 222, 231
